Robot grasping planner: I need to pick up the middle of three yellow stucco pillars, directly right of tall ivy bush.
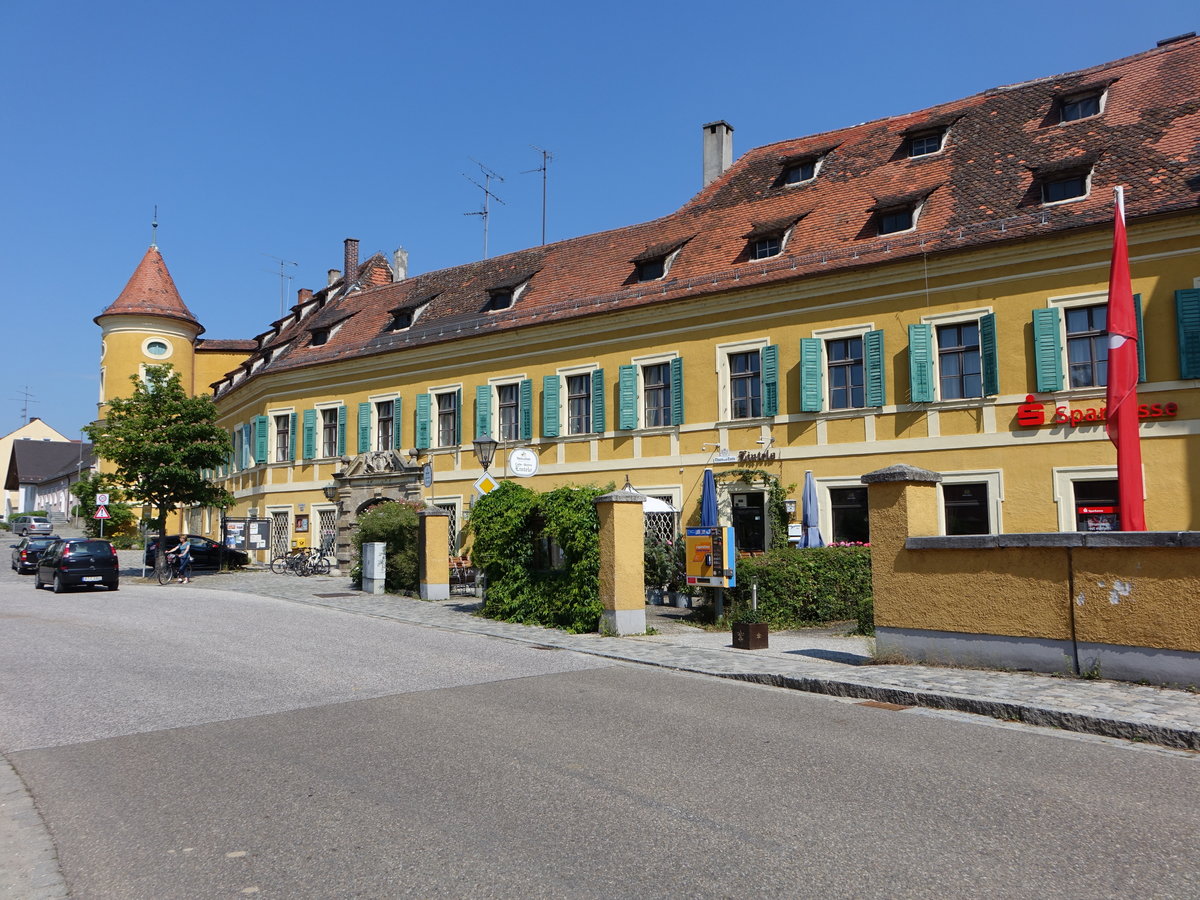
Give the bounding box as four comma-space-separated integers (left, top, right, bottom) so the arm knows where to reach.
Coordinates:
595, 490, 646, 635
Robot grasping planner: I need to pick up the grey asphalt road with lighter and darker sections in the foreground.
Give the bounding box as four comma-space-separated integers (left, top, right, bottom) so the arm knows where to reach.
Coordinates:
0, 570, 1200, 900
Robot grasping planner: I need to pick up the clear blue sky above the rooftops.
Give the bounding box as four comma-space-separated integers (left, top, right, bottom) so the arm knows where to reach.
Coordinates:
0, 0, 1200, 437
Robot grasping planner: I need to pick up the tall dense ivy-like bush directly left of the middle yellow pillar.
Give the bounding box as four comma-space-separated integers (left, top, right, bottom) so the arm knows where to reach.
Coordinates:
468, 481, 612, 634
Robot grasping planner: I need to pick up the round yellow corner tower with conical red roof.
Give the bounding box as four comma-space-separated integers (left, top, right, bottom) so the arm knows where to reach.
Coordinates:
95, 244, 204, 419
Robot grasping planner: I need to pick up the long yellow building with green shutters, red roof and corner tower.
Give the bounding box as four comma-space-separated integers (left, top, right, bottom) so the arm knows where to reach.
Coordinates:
97, 37, 1200, 571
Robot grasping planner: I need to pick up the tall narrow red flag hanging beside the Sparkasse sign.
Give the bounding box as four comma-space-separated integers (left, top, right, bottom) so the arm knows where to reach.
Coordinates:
1104, 187, 1146, 532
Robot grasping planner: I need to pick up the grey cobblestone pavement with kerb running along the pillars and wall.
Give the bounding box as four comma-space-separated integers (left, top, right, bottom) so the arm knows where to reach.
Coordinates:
131, 554, 1200, 750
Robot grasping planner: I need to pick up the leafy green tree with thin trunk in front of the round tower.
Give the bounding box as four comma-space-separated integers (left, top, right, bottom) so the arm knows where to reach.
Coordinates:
84, 365, 233, 564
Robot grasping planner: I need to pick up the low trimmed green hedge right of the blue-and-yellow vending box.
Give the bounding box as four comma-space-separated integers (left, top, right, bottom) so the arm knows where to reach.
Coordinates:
726, 547, 875, 634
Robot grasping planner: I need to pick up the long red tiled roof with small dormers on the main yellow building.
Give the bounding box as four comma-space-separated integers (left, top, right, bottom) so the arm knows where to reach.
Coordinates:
218, 37, 1200, 398
